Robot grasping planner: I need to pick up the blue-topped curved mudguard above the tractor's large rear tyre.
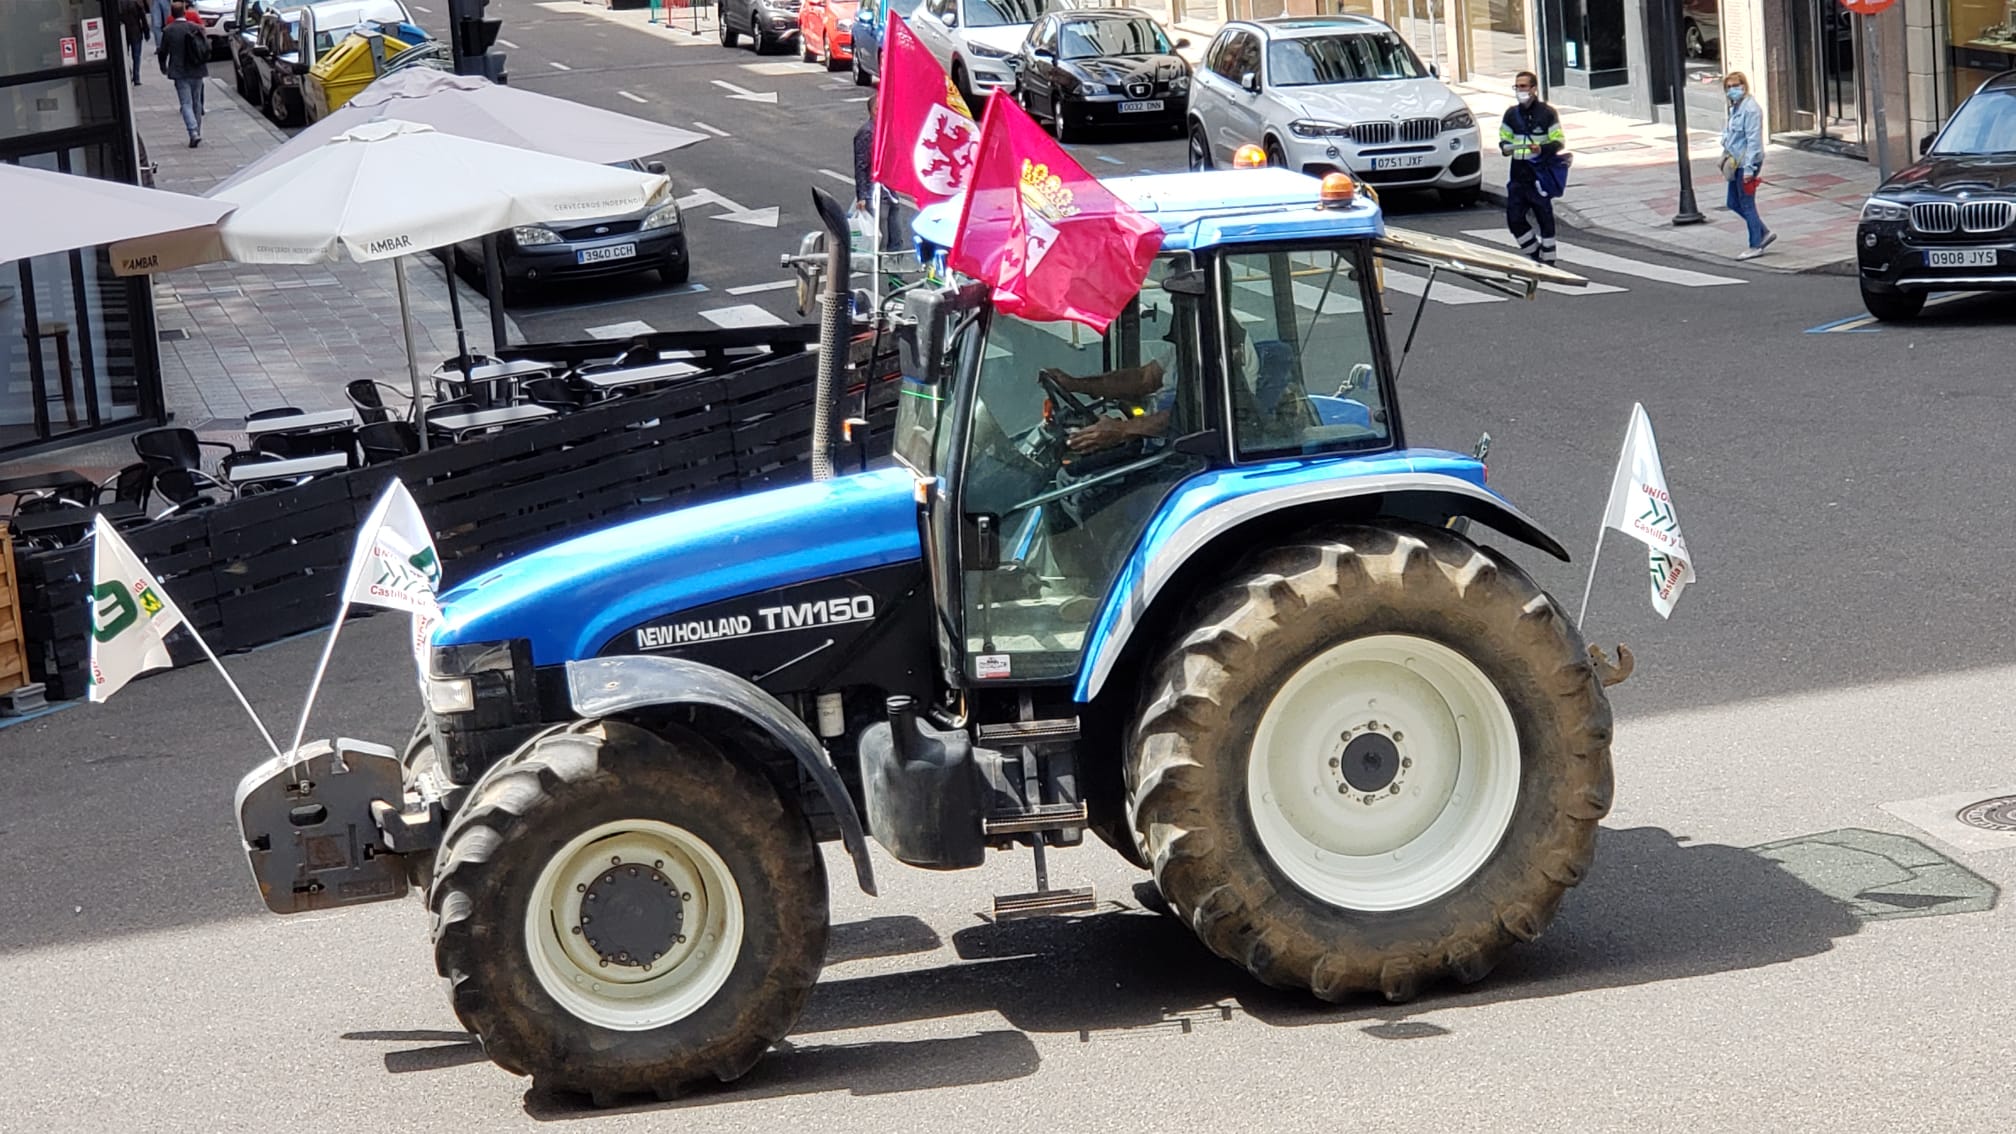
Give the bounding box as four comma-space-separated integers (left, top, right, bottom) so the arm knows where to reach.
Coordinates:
1075, 460, 1568, 702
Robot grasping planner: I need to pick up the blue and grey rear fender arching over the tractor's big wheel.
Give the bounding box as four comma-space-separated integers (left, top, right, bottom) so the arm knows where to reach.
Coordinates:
1075, 468, 1568, 702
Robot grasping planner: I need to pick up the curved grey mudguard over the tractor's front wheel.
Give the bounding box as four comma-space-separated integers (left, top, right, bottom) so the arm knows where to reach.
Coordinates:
566, 656, 875, 894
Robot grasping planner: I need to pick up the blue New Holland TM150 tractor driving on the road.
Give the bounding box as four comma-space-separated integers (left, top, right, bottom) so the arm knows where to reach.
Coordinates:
240, 169, 1611, 1102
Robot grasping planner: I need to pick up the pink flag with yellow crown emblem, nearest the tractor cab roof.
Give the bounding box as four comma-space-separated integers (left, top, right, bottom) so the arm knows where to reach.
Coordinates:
948, 99, 1161, 333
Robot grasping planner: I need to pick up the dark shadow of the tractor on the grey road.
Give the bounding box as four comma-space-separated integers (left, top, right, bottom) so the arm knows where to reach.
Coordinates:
516, 827, 1861, 1120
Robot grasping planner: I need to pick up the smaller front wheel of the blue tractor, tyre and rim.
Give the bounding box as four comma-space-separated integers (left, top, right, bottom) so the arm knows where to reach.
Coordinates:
429, 720, 827, 1106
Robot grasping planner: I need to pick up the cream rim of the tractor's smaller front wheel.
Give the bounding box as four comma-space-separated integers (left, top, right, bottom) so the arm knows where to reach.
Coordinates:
524, 819, 744, 1031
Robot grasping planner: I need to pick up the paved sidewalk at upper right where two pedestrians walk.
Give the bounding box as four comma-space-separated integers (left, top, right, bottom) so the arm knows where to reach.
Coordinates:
1452, 85, 1877, 274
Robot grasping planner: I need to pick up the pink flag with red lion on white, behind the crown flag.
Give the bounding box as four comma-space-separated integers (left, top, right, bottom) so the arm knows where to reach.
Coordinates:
873, 12, 980, 208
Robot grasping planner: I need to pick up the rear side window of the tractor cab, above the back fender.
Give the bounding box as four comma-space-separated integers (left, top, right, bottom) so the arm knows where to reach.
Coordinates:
1220, 244, 1393, 458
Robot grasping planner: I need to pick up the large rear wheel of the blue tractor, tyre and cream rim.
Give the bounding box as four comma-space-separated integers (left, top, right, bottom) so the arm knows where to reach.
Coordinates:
1127, 525, 1611, 1001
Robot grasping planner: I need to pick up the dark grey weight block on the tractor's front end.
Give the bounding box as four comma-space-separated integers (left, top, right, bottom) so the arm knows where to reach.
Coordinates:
238, 739, 417, 914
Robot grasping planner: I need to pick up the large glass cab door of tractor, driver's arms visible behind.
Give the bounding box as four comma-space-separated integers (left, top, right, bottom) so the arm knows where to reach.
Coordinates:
960, 256, 1202, 680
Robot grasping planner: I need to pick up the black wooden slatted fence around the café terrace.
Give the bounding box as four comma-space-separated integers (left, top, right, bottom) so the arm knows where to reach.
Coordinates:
18, 327, 895, 700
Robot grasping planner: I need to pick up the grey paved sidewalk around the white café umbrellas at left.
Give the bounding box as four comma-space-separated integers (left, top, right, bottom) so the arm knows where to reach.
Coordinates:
0, 63, 520, 476
